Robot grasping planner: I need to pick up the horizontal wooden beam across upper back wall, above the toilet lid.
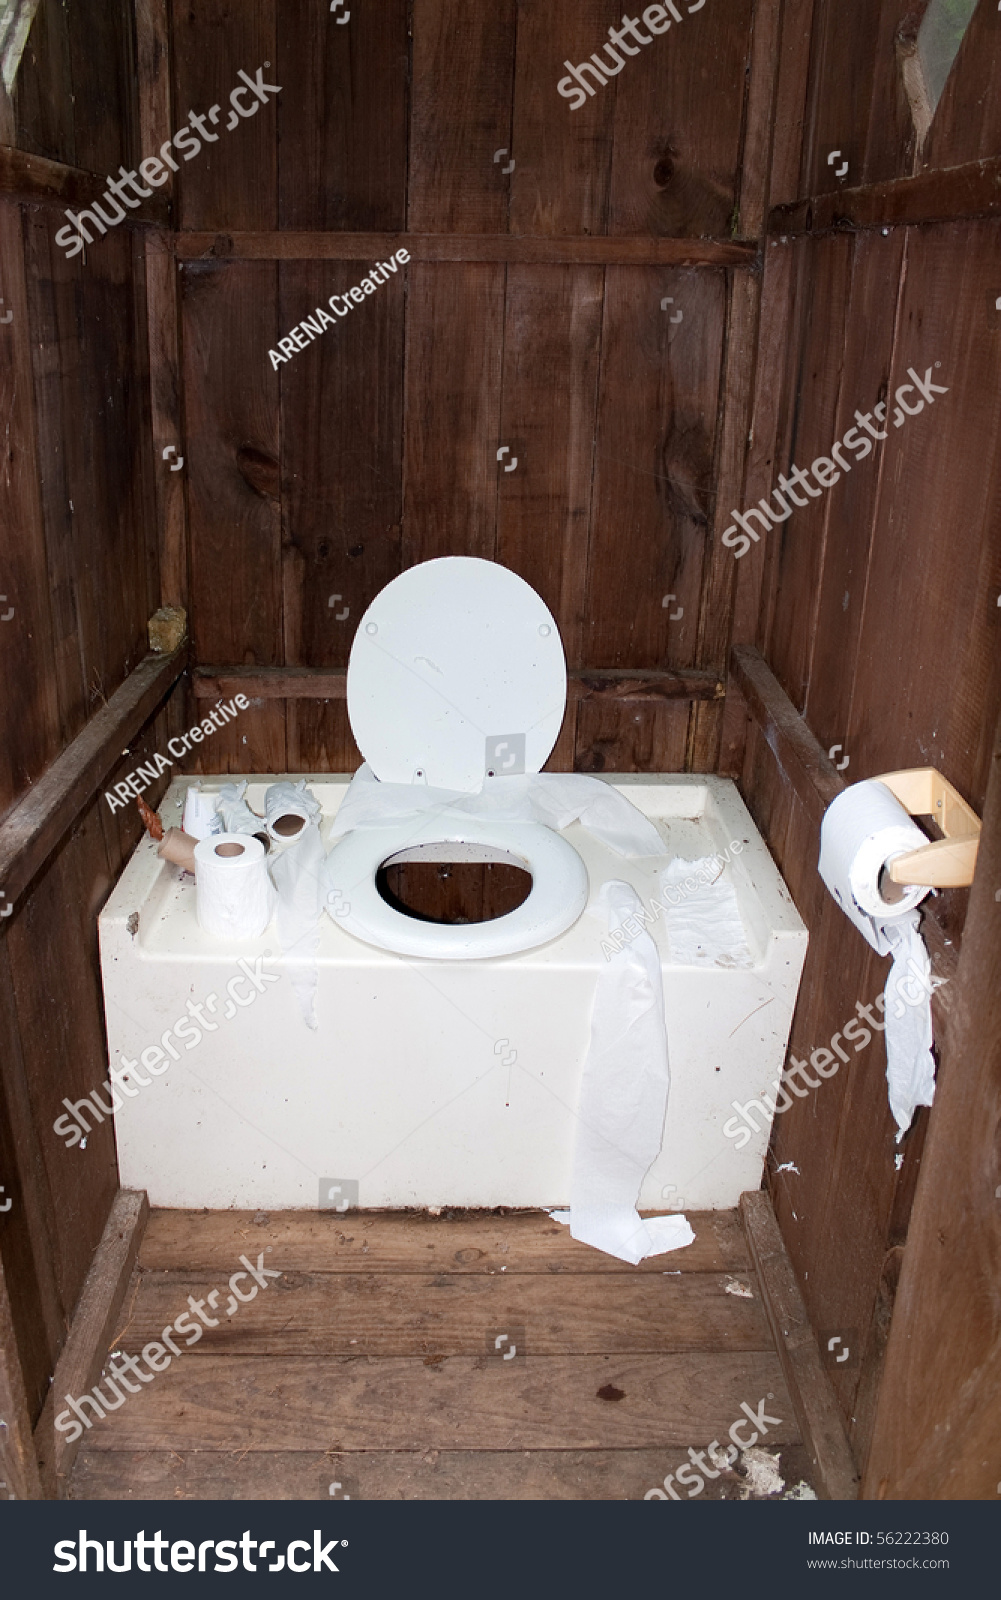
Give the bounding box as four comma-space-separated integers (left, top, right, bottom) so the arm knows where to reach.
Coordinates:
174, 229, 748, 267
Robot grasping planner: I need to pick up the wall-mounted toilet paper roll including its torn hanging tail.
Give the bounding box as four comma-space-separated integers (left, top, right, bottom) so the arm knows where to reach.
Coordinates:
819, 778, 935, 1142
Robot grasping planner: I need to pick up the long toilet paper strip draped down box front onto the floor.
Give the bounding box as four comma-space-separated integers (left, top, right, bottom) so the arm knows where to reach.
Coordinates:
550, 880, 696, 1266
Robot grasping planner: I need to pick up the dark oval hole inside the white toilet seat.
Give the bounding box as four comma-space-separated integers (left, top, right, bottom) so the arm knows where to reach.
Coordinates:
376, 842, 532, 925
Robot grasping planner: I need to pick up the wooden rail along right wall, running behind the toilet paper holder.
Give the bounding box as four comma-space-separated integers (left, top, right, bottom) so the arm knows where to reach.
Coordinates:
731, 645, 958, 1004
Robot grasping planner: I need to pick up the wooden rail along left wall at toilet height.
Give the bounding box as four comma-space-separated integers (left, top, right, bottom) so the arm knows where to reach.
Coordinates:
0, 645, 187, 928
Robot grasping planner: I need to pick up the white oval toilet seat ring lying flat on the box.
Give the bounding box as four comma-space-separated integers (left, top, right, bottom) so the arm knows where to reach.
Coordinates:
325, 814, 588, 962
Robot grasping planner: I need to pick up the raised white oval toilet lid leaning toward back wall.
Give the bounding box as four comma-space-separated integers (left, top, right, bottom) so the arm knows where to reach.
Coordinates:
347, 555, 566, 794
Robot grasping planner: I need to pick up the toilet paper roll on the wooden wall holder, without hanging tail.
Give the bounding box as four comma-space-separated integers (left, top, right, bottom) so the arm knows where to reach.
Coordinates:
820, 778, 929, 955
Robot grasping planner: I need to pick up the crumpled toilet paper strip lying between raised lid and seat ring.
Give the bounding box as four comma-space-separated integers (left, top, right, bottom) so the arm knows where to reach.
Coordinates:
331, 762, 664, 856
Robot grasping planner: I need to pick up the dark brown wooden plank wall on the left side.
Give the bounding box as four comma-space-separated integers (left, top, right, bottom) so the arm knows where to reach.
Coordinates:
0, 0, 177, 1416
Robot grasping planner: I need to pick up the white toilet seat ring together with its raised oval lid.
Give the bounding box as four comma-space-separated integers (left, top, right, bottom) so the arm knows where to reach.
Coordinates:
326, 555, 588, 962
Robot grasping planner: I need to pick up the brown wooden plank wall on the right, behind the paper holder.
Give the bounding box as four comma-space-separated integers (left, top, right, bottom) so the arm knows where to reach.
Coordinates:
728, 0, 1001, 1494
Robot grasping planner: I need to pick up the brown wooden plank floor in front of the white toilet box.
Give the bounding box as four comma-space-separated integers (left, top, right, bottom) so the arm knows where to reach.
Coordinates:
66, 1211, 816, 1499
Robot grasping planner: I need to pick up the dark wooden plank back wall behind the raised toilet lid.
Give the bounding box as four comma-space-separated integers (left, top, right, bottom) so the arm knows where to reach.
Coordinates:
171, 0, 752, 771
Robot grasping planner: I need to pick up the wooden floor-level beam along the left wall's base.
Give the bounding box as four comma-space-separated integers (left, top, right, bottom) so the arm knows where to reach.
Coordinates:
35, 1189, 149, 1499
